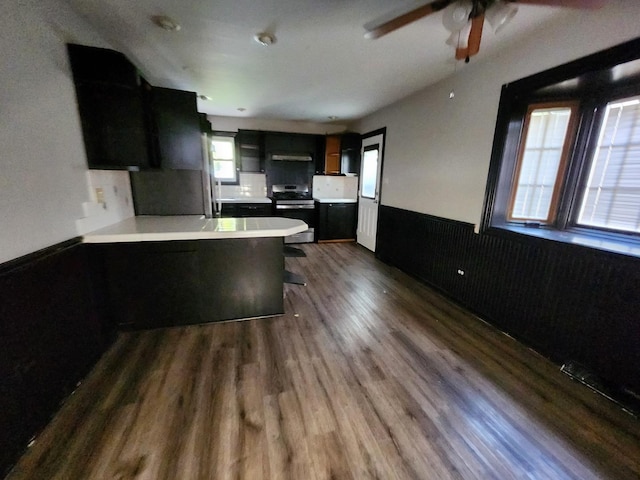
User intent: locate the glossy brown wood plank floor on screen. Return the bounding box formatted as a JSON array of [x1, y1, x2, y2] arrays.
[[8, 244, 640, 480]]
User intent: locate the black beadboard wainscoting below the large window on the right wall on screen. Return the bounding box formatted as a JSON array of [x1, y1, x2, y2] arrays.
[[376, 206, 640, 398]]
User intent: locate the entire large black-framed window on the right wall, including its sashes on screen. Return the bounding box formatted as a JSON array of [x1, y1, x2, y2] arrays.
[[482, 39, 640, 251]]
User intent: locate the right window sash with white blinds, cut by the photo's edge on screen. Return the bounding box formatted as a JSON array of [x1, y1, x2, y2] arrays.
[[576, 95, 640, 233]]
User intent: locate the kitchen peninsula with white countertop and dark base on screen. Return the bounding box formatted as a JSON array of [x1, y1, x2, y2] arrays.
[[83, 215, 307, 329]]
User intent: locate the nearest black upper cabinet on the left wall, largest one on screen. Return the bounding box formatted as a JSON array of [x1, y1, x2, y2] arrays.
[[67, 44, 149, 169]]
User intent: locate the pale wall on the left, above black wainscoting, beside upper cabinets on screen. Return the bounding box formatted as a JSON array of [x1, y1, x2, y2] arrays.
[[0, 0, 132, 262]]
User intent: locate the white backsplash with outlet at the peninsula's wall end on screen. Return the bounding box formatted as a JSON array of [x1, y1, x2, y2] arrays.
[[76, 170, 135, 235]]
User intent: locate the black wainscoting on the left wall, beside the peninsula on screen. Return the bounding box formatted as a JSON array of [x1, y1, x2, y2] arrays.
[[0, 240, 112, 477]]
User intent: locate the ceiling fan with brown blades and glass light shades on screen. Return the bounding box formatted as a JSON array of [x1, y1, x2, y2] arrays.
[[365, 0, 607, 62]]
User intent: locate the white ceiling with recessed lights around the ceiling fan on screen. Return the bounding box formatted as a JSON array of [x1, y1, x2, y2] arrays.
[[66, 0, 564, 123]]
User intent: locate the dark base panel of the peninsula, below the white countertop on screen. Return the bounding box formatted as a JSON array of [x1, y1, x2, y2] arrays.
[[92, 237, 284, 329]]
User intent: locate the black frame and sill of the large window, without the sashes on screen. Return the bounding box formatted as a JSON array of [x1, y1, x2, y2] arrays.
[[480, 39, 640, 256]]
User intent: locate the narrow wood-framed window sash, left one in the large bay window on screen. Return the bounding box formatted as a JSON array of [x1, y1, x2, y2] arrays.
[[507, 102, 578, 224]]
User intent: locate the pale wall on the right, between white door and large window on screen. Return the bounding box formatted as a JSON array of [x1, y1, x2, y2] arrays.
[[354, 0, 640, 224]]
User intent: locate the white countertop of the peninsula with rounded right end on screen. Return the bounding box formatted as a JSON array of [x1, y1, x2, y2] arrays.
[[83, 215, 308, 243]]
